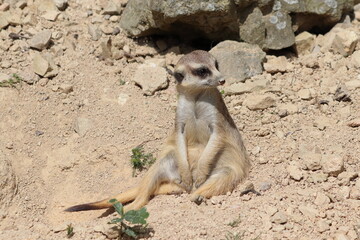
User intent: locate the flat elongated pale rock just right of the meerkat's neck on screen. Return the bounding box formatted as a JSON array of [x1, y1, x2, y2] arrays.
[[224, 79, 269, 95]]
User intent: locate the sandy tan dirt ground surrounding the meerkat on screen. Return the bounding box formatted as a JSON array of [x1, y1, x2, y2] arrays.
[[0, 1, 360, 240]]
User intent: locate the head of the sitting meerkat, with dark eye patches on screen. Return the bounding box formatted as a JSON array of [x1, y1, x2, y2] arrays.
[[174, 50, 225, 88]]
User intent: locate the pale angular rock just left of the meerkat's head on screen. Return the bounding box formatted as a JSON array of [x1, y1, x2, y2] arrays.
[[132, 63, 169, 96]]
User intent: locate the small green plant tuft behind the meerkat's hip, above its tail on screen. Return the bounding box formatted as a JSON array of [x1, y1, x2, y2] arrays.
[[130, 146, 156, 177]]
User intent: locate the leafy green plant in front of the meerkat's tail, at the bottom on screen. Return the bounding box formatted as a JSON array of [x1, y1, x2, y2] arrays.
[[109, 199, 149, 238]]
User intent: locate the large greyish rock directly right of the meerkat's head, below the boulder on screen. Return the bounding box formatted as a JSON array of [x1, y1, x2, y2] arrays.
[[210, 40, 265, 82]]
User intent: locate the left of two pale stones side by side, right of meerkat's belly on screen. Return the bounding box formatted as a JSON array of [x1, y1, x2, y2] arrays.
[[299, 144, 321, 171]]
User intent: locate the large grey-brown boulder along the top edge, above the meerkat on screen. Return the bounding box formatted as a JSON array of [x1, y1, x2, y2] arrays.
[[120, 0, 354, 50]]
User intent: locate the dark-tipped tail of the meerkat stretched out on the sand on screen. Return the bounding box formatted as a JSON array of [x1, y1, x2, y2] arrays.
[[65, 187, 138, 212]]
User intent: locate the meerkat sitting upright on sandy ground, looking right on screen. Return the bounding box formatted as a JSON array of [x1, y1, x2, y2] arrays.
[[65, 50, 250, 212]]
